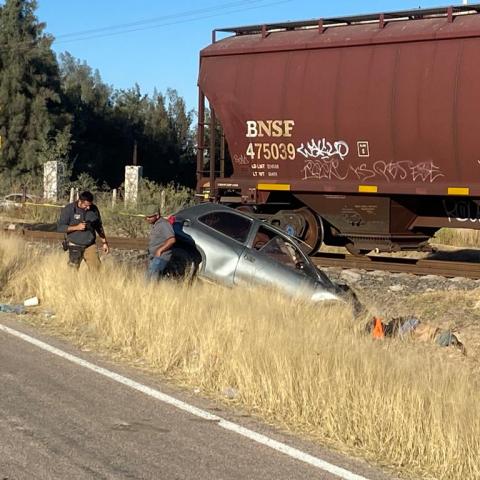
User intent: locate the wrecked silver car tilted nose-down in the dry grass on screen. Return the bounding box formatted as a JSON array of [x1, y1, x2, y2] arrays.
[[169, 203, 360, 311]]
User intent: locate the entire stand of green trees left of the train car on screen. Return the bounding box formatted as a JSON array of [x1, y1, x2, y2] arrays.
[[0, 0, 195, 187]]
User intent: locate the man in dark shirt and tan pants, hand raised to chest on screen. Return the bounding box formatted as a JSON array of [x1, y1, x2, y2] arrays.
[[57, 192, 110, 268]]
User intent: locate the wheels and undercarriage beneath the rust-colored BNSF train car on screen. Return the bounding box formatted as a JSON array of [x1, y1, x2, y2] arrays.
[[205, 179, 480, 255]]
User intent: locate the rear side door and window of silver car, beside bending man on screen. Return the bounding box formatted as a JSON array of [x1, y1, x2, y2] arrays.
[[194, 210, 253, 285]]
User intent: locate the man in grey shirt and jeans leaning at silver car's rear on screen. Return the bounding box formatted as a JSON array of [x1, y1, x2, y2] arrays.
[[145, 205, 175, 280]]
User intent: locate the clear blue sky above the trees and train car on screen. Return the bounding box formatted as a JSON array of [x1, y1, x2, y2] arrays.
[[32, 0, 472, 109]]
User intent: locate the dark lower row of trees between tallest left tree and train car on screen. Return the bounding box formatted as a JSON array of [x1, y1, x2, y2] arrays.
[[59, 53, 195, 186]]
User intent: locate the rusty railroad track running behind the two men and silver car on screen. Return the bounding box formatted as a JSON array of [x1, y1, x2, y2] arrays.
[[6, 229, 480, 279]]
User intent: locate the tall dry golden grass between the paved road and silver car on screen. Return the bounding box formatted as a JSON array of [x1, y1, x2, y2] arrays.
[[0, 240, 480, 480]]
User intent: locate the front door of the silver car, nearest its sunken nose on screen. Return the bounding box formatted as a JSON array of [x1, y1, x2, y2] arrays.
[[234, 224, 316, 294]]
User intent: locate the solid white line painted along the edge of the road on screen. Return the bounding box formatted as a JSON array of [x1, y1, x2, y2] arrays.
[[0, 324, 368, 480]]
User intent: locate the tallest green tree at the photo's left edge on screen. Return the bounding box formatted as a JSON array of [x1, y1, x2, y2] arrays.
[[0, 0, 70, 175]]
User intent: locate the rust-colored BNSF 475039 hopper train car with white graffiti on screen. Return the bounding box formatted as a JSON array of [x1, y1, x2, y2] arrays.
[[197, 5, 480, 253]]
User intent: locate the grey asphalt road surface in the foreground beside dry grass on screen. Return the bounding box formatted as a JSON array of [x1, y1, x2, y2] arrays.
[[0, 314, 396, 480]]
